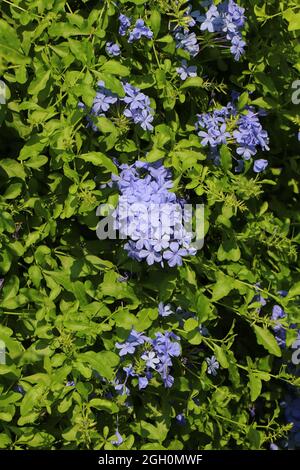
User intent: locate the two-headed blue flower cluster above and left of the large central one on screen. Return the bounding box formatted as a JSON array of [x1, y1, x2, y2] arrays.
[[78, 81, 154, 132]]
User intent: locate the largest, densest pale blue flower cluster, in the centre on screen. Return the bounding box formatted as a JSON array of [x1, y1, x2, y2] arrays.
[[112, 160, 196, 267]]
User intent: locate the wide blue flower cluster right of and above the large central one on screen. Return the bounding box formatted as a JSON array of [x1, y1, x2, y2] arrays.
[[196, 102, 269, 173]]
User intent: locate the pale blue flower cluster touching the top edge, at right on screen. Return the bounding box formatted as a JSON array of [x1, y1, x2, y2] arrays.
[[200, 0, 246, 61]]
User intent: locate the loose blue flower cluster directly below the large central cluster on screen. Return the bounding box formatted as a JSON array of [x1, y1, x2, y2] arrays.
[[115, 329, 181, 395]]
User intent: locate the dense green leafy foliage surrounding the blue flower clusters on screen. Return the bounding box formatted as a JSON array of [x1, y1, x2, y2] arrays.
[[0, 0, 300, 449]]
